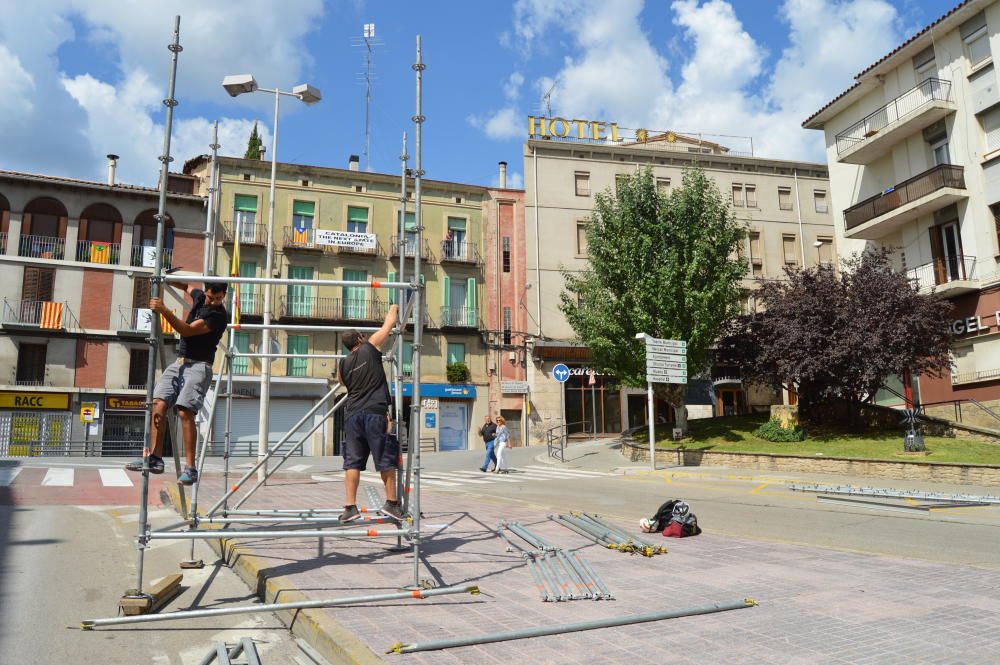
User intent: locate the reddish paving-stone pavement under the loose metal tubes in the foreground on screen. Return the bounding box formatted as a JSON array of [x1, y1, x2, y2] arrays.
[[188, 479, 1000, 665]]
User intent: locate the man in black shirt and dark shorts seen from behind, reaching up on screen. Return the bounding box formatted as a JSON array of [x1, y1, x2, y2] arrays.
[[340, 305, 405, 522]]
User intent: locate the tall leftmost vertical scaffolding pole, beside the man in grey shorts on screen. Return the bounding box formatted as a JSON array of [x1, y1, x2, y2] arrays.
[[131, 15, 183, 596]]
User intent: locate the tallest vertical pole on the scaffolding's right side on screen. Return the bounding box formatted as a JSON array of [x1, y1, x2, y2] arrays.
[[409, 35, 426, 589]]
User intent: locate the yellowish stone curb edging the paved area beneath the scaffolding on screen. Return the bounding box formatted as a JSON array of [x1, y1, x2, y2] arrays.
[[166, 485, 388, 665]]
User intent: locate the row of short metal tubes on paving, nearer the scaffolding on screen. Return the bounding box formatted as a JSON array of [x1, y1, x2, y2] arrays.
[[497, 520, 615, 602]]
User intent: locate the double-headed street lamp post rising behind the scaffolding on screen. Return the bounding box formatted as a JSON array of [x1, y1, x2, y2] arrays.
[[222, 74, 322, 480]]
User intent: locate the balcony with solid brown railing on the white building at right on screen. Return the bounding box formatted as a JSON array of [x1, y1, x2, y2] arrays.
[[844, 164, 968, 240]]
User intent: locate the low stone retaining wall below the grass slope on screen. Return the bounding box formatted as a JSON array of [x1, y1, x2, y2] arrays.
[[622, 442, 1000, 485]]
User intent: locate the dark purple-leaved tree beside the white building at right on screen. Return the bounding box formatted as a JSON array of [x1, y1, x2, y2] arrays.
[[721, 248, 952, 423]]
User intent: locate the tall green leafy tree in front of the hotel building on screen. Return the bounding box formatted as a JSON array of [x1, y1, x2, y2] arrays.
[[559, 168, 747, 432]]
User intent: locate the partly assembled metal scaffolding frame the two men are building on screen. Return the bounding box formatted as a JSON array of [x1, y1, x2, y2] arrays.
[[112, 23, 434, 627]]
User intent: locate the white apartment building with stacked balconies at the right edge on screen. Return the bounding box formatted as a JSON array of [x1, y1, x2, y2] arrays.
[[803, 0, 1000, 415]]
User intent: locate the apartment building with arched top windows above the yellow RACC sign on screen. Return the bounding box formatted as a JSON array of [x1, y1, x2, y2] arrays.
[[0, 166, 205, 455]]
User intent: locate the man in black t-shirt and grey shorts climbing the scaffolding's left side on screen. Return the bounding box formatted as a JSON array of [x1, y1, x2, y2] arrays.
[[125, 282, 229, 485]]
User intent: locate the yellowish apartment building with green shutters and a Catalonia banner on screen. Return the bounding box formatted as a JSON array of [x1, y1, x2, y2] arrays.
[[184, 156, 489, 454]]
